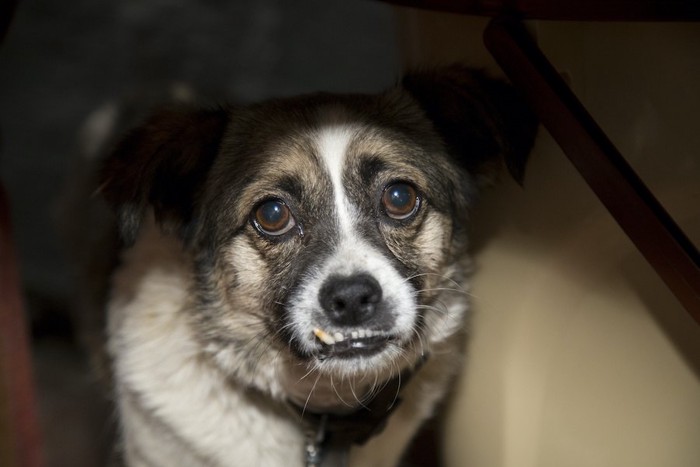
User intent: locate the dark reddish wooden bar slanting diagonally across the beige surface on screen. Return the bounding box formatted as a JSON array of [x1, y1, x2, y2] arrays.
[[484, 18, 700, 324]]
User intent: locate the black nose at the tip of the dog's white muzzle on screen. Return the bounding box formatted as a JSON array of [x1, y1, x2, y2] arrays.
[[318, 274, 382, 326]]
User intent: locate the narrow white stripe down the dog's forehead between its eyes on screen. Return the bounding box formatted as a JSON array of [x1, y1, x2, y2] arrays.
[[318, 125, 355, 236]]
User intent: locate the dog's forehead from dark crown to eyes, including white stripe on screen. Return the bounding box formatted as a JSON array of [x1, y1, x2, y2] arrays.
[[205, 99, 462, 245]]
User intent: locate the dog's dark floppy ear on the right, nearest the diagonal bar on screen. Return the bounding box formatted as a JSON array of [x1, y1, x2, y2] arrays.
[[401, 65, 537, 183]]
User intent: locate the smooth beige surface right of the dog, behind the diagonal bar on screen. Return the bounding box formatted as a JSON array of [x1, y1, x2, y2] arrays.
[[397, 9, 700, 467]]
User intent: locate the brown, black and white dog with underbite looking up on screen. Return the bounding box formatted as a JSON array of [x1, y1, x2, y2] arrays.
[[99, 65, 537, 467]]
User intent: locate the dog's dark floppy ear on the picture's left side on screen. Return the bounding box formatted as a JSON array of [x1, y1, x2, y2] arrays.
[[99, 109, 229, 244]]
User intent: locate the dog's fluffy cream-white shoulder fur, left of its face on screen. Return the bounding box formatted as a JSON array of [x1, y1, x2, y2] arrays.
[[108, 222, 301, 465]]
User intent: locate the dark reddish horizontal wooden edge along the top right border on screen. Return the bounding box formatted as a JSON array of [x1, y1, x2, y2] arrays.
[[383, 0, 700, 21]]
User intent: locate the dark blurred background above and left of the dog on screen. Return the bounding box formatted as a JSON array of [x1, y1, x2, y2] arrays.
[[0, 0, 400, 467]]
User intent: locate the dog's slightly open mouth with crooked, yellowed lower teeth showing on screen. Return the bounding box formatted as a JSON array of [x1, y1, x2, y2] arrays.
[[313, 328, 395, 359]]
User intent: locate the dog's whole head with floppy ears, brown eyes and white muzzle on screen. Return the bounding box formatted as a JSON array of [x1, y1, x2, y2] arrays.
[[103, 67, 536, 408]]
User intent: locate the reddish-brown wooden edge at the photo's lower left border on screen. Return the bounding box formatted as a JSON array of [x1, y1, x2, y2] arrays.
[[0, 184, 42, 467]]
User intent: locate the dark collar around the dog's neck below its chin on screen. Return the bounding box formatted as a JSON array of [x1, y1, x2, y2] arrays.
[[287, 355, 428, 467]]
